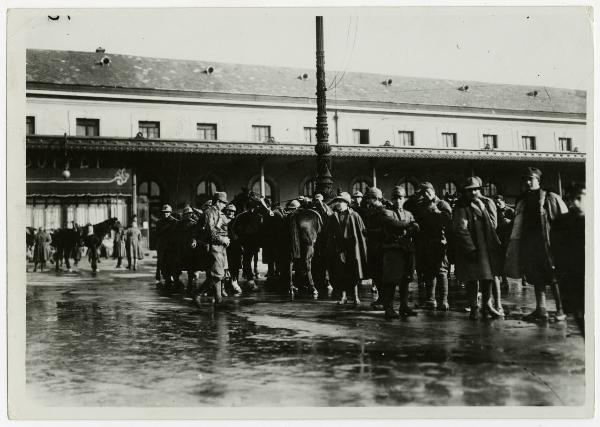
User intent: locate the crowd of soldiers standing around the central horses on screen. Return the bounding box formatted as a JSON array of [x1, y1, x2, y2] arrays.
[[150, 167, 585, 327]]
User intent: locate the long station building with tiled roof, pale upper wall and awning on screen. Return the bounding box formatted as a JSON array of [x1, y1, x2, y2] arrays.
[[25, 48, 587, 248]]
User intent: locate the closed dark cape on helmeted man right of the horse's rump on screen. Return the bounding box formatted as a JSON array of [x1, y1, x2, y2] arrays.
[[325, 208, 367, 285]]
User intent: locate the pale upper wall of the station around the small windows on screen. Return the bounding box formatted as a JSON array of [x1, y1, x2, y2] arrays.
[[27, 97, 586, 152]]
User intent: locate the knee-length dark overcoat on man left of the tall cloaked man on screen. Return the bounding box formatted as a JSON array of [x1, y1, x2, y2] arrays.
[[453, 196, 503, 281]]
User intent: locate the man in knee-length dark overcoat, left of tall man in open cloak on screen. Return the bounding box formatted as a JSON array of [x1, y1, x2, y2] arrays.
[[452, 176, 504, 319]]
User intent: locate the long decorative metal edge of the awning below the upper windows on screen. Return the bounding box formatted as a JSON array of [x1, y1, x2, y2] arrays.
[[27, 135, 586, 163]]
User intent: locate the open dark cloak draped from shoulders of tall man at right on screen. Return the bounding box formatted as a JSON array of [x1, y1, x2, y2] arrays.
[[504, 190, 568, 280]]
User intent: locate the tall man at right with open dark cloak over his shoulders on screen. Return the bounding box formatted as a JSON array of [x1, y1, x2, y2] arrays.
[[504, 167, 568, 321]]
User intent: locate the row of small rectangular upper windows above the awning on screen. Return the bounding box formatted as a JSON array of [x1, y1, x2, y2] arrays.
[[27, 116, 573, 151]]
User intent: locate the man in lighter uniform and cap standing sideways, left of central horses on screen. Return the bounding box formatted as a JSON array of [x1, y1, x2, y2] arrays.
[[196, 191, 230, 305]]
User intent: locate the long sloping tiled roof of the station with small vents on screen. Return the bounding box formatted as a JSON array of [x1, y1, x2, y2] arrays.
[[27, 49, 586, 114]]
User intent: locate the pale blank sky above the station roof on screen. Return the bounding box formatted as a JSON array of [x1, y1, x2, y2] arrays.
[[16, 7, 593, 89]]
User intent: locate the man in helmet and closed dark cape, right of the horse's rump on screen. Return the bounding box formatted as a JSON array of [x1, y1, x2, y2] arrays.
[[325, 192, 367, 305]]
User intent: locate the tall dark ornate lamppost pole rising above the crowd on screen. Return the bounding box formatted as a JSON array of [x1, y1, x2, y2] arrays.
[[315, 16, 333, 200]]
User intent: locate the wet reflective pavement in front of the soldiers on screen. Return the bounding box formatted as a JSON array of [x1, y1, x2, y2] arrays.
[[26, 259, 585, 406]]
